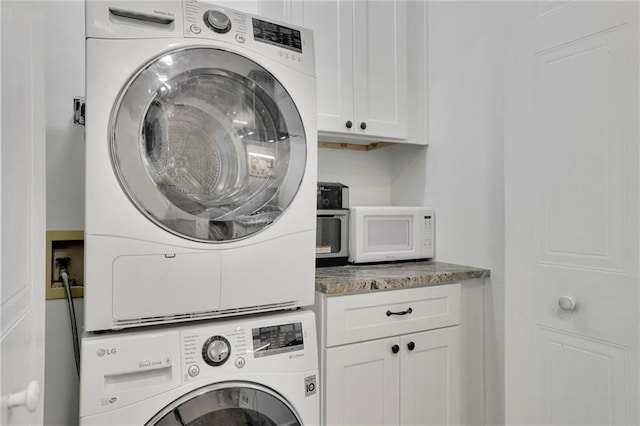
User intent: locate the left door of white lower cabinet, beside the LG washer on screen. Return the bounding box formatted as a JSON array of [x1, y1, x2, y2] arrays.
[[324, 338, 400, 426]]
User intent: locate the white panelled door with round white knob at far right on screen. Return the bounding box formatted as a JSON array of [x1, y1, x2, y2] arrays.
[[505, 1, 639, 425]]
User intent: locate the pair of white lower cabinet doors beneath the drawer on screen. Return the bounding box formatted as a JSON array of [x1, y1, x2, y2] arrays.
[[324, 326, 460, 425]]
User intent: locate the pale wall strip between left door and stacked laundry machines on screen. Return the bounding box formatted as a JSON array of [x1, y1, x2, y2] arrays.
[[44, 1, 84, 426]]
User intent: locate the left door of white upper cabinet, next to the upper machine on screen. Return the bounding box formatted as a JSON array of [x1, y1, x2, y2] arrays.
[[294, 0, 354, 133]]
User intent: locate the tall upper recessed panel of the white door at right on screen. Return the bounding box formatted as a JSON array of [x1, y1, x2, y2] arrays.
[[533, 26, 633, 272]]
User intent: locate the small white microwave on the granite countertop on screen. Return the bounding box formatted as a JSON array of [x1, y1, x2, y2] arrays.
[[349, 207, 435, 263]]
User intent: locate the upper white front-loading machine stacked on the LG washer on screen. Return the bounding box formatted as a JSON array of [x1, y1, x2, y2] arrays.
[[84, 0, 317, 331]]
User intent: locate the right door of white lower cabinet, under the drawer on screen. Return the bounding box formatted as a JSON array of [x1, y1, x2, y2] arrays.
[[400, 326, 461, 425]]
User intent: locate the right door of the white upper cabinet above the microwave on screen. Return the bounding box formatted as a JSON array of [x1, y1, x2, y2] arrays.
[[353, 0, 408, 139]]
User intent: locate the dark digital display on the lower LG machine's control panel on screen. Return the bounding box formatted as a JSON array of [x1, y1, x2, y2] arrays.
[[251, 322, 304, 358]]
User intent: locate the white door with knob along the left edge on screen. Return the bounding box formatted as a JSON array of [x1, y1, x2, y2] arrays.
[[0, 1, 46, 426]]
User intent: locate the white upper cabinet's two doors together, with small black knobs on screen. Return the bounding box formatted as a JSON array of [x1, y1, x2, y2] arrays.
[[292, 0, 408, 141]]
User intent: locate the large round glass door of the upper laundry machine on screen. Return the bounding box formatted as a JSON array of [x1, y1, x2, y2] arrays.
[[111, 47, 307, 242]]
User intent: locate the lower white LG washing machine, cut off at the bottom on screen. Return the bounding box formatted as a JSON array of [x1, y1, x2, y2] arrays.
[[80, 310, 320, 426]]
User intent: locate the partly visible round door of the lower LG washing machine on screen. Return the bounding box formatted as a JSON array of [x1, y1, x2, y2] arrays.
[[145, 382, 302, 426]]
